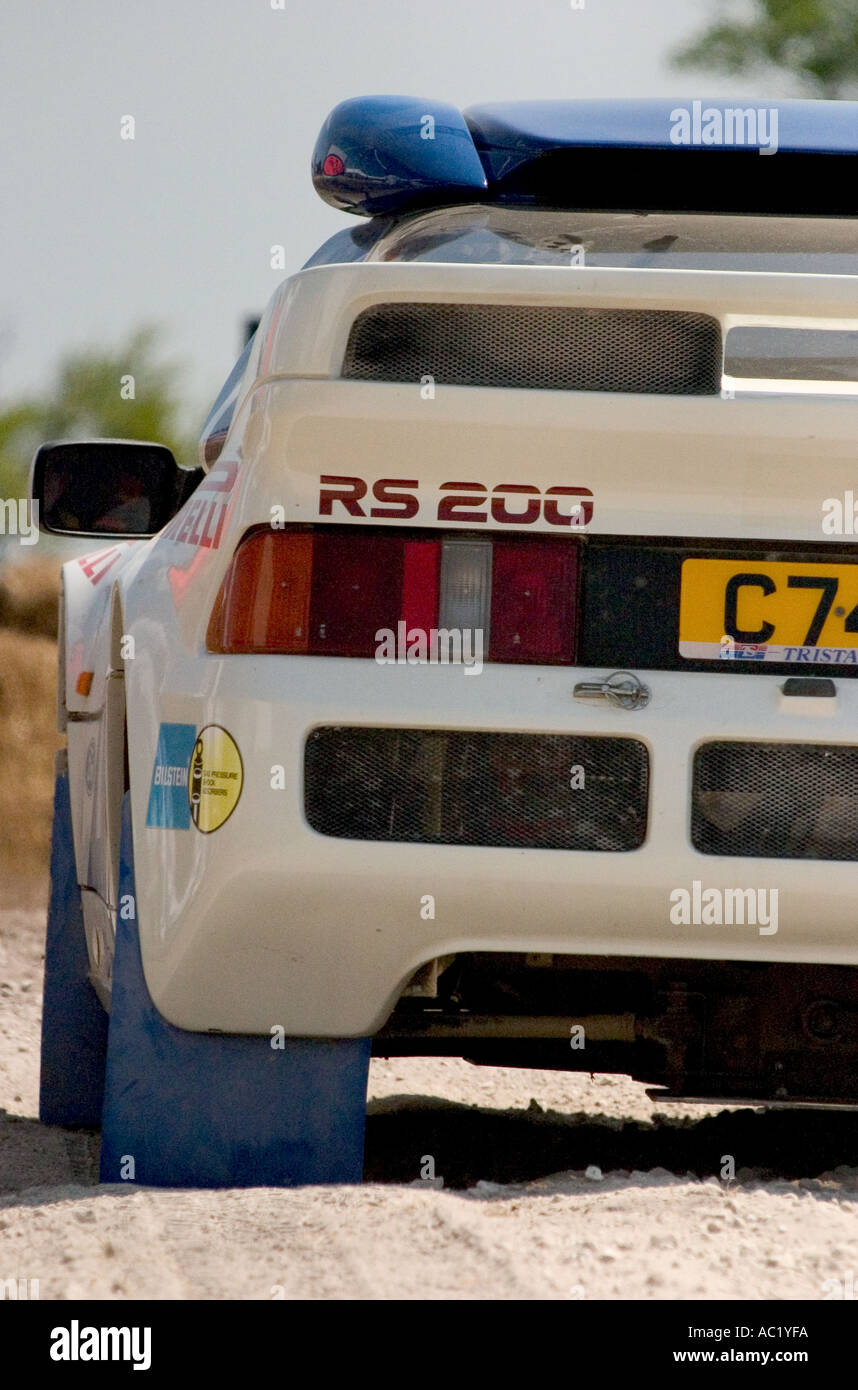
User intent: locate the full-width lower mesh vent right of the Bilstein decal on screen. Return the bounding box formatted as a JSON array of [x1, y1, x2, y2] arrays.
[[305, 728, 649, 851]]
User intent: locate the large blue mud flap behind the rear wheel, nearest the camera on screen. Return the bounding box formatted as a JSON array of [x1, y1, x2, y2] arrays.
[[102, 795, 370, 1187]]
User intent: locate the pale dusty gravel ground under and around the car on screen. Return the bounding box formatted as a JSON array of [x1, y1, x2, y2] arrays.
[[0, 910, 858, 1300]]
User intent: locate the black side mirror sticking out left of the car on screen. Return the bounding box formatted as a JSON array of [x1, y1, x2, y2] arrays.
[[29, 439, 203, 537]]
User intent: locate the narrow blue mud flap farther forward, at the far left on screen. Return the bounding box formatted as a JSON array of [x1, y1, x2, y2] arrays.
[[39, 755, 107, 1126]]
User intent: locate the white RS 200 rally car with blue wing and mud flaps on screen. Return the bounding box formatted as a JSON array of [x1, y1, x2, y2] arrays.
[[32, 97, 858, 1186]]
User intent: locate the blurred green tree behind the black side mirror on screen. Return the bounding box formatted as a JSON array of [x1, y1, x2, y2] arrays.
[[0, 328, 196, 505]]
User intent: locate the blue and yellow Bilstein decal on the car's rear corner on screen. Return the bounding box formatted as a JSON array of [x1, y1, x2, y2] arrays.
[[146, 724, 245, 835]]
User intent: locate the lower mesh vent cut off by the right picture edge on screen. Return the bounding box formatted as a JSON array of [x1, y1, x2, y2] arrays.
[[691, 744, 858, 859]]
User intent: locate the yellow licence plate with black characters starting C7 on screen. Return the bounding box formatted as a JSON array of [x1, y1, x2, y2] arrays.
[[679, 559, 858, 666]]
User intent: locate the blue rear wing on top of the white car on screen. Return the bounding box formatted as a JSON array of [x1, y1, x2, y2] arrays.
[[313, 96, 858, 217]]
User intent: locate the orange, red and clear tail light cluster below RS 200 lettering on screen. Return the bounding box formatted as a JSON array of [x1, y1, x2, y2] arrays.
[[207, 527, 578, 664]]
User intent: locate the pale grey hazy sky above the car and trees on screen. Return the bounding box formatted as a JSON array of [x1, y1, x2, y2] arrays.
[[0, 0, 795, 424]]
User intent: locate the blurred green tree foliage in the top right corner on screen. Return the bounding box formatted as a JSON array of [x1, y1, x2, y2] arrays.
[[673, 0, 858, 97]]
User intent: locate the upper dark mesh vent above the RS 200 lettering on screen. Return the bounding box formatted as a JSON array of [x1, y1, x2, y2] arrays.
[[342, 304, 722, 396]]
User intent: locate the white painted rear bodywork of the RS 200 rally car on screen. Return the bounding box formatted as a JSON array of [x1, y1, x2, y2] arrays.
[[58, 264, 858, 1037]]
